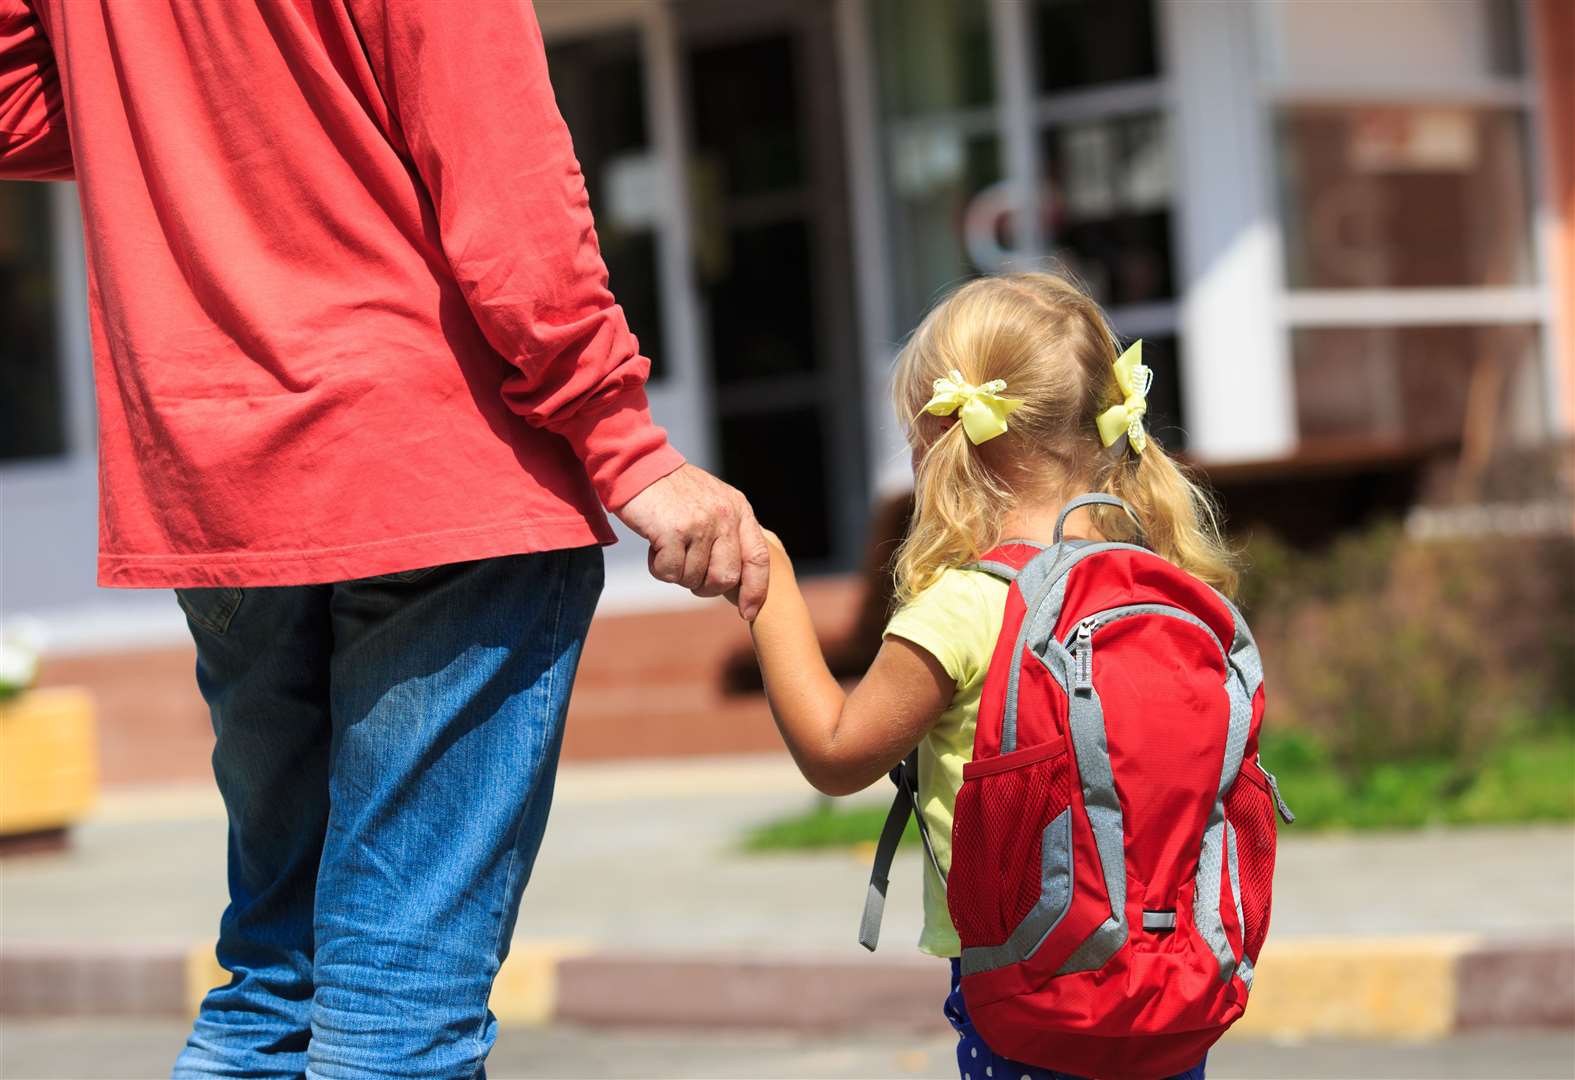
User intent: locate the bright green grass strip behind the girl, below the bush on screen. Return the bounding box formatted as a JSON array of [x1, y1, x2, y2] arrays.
[[742, 715, 1575, 852]]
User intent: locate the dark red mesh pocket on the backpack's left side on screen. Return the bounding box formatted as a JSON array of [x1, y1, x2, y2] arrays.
[[947, 745, 1071, 948]]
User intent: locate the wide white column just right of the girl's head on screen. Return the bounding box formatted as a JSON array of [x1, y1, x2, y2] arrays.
[[1159, 0, 1296, 461]]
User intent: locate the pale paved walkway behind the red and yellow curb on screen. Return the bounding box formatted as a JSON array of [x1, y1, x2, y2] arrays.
[[0, 756, 1575, 959]]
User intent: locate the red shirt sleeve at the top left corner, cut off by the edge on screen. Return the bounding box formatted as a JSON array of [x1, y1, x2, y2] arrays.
[[0, 0, 72, 179]]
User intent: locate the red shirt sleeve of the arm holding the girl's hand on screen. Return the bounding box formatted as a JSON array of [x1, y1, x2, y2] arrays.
[[348, 0, 684, 509]]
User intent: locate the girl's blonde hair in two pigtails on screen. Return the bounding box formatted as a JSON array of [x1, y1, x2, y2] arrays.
[[893, 274, 1236, 603]]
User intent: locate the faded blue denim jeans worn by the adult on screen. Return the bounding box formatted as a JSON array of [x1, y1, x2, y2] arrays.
[[175, 548, 602, 1080]]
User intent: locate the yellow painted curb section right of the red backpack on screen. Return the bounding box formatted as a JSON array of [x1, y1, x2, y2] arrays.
[[1227, 937, 1477, 1039]]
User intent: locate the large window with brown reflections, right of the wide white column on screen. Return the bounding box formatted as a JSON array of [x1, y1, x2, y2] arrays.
[[1263, 0, 1544, 452]]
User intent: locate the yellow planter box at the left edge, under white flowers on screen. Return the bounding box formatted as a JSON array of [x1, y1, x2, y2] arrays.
[[0, 686, 98, 836]]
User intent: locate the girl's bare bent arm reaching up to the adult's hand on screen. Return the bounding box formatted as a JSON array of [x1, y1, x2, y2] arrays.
[[751, 534, 956, 795]]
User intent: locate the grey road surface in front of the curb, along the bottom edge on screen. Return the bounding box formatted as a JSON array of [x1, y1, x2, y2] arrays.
[[0, 1019, 1575, 1080]]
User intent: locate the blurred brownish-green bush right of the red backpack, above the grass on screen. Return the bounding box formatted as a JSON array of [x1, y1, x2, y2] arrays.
[[1241, 524, 1575, 787]]
